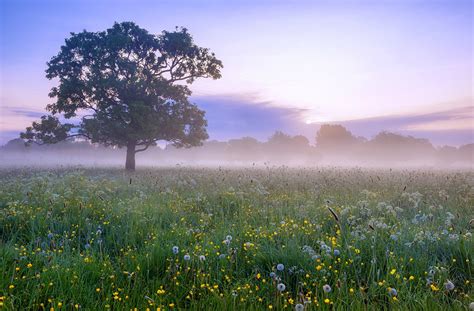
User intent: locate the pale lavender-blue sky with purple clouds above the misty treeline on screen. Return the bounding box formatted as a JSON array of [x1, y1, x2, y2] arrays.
[[0, 0, 474, 146]]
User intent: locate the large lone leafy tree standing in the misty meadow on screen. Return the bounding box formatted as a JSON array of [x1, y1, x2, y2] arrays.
[[20, 22, 223, 170]]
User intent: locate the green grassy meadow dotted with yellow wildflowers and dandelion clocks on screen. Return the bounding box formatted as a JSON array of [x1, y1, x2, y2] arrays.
[[0, 167, 474, 311]]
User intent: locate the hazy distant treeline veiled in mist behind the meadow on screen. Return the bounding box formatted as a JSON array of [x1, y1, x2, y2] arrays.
[[0, 124, 474, 166]]
